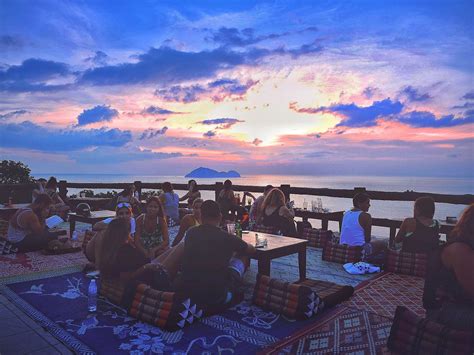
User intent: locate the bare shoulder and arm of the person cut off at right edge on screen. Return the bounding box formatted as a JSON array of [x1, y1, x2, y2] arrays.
[[441, 243, 474, 300]]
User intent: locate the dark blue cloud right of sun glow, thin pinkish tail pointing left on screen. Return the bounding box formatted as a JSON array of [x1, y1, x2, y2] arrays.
[[290, 98, 403, 127]]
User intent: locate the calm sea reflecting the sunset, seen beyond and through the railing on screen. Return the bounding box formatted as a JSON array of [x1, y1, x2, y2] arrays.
[[33, 173, 474, 236]]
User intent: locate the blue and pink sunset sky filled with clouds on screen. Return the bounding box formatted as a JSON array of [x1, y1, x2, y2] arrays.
[[0, 0, 474, 177]]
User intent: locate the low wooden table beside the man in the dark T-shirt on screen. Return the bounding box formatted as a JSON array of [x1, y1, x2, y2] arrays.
[[242, 232, 308, 280]]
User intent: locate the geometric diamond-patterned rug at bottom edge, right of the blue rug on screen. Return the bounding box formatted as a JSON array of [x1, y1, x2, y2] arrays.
[[261, 306, 392, 355]]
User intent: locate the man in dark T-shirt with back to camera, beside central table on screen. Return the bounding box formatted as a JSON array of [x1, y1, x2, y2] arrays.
[[175, 200, 255, 307]]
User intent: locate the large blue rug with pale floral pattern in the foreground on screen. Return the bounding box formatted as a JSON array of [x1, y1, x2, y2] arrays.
[[0, 272, 326, 354]]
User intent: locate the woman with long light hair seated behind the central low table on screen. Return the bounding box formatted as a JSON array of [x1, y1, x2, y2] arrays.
[[258, 188, 297, 237]]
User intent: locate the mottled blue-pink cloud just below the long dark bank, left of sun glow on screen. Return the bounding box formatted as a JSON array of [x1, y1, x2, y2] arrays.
[[155, 78, 258, 103]]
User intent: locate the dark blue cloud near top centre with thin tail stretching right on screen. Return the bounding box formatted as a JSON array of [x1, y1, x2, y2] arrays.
[[206, 27, 317, 47]]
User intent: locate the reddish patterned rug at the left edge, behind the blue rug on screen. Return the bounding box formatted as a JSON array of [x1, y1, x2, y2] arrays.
[[0, 251, 87, 281]]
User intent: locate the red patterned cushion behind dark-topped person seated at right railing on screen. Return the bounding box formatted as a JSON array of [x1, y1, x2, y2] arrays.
[[385, 250, 428, 277]]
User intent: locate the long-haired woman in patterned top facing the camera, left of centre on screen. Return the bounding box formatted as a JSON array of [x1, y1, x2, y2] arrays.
[[135, 196, 169, 260]]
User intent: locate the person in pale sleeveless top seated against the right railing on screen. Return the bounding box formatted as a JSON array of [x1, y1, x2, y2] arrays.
[[340, 192, 386, 256]]
